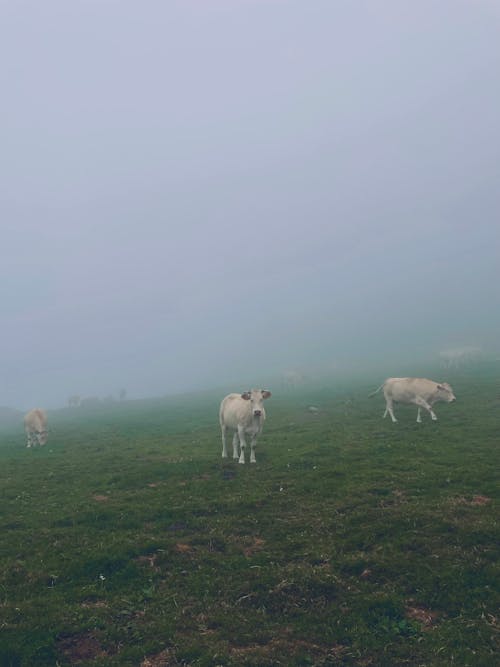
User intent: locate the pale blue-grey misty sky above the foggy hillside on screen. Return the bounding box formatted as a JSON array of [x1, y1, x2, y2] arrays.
[[0, 0, 500, 408]]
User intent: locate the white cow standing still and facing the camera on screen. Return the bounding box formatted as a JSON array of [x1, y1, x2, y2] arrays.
[[219, 389, 271, 463]]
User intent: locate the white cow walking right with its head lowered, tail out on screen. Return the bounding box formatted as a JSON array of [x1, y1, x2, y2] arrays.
[[370, 378, 456, 423]]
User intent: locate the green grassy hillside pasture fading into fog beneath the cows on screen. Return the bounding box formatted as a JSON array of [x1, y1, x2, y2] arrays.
[[0, 369, 500, 667]]
